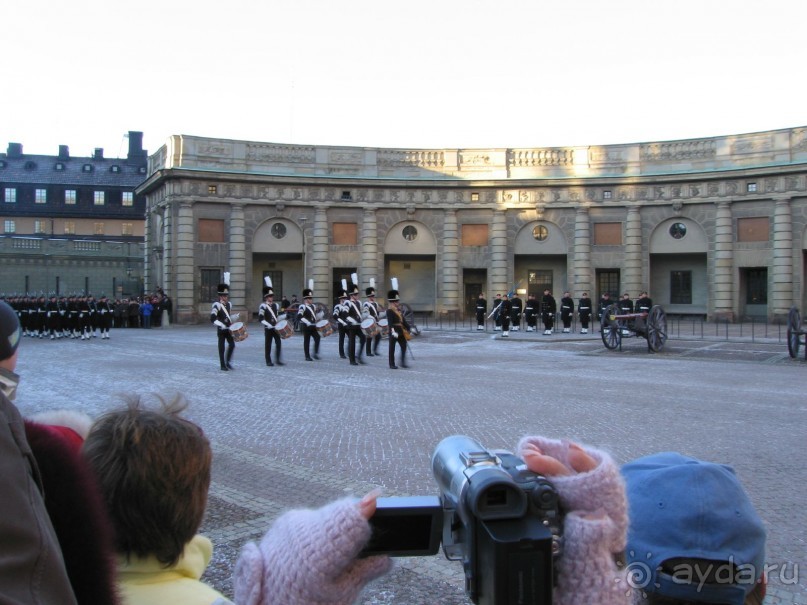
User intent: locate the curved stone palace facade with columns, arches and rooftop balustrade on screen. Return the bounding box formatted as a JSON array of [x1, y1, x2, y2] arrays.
[[136, 127, 807, 323]]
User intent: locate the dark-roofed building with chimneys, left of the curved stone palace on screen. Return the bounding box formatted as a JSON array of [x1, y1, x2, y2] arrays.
[[0, 131, 148, 297]]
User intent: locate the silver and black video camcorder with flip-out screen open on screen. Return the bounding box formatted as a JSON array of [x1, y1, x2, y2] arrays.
[[363, 435, 563, 605]]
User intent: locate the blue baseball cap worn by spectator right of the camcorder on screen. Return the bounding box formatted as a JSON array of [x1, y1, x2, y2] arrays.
[[622, 452, 765, 605]]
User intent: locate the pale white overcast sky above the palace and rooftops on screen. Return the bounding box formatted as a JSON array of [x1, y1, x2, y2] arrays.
[[0, 0, 807, 157]]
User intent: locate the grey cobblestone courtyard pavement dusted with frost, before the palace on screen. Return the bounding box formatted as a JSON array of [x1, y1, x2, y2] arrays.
[[17, 325, 807, 605]]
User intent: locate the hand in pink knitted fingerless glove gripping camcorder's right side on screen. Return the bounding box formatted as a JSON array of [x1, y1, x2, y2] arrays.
[[516, 436, 631, 605]]
